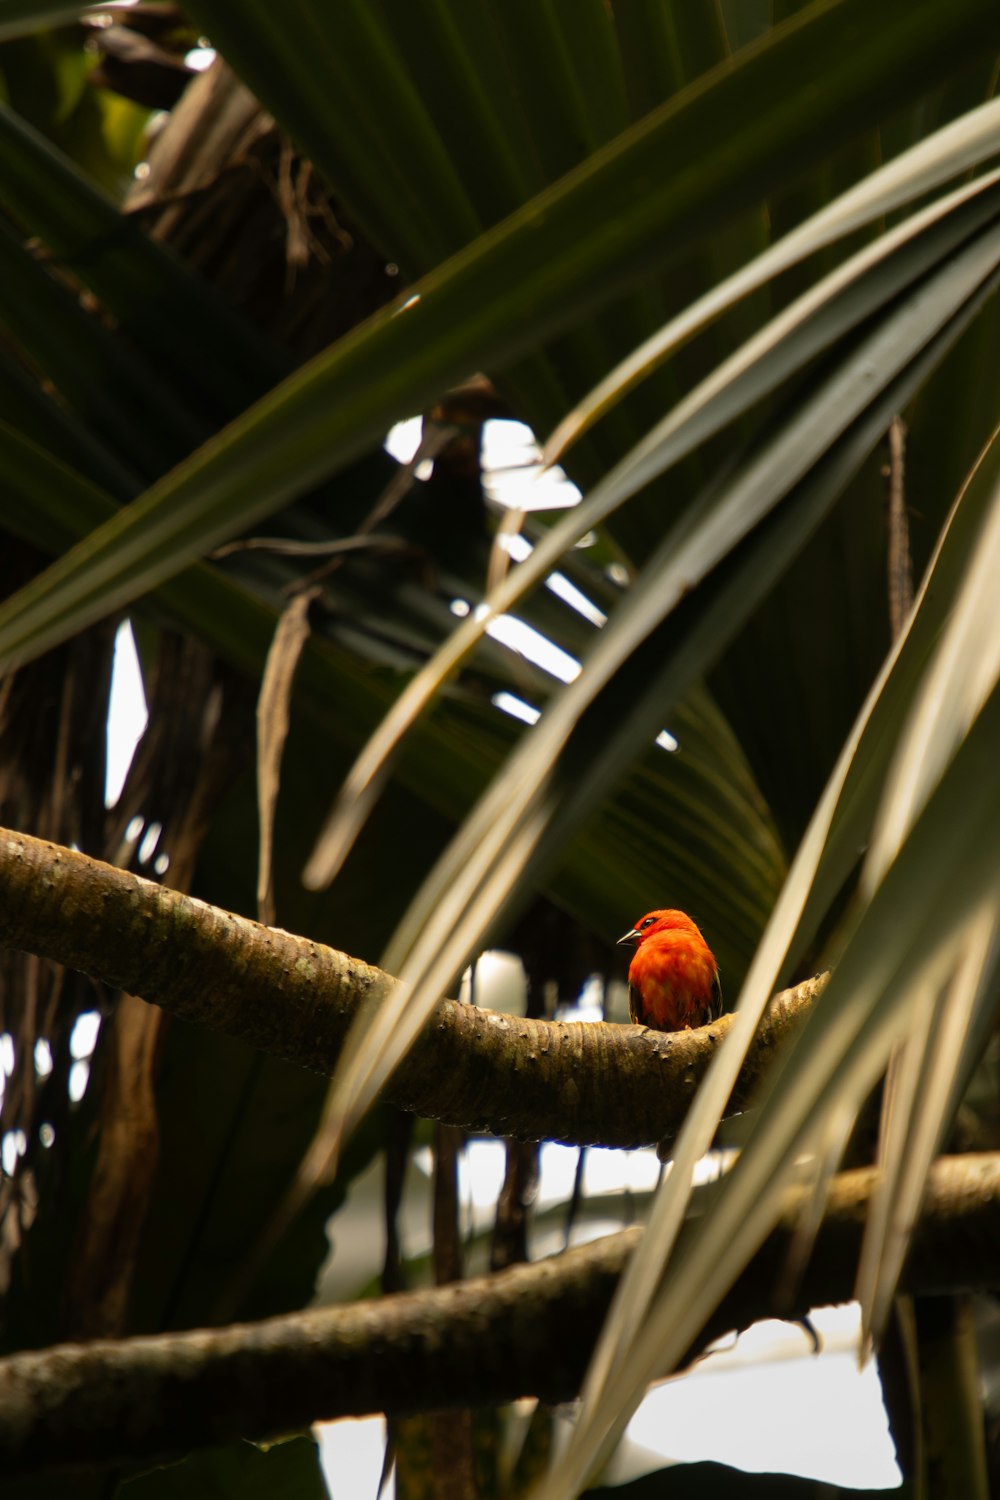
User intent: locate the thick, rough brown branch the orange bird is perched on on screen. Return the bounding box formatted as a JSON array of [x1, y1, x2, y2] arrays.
[[0, 830, 825, 1146]]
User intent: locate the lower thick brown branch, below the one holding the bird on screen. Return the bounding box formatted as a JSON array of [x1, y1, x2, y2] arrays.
[[0, 1155, 1000, 1473]]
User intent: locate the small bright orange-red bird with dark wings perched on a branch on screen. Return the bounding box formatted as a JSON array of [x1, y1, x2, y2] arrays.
[[618, 912, 723, 1031]]
